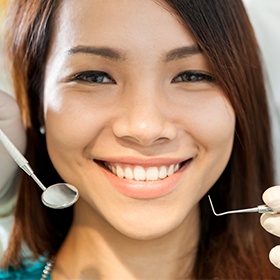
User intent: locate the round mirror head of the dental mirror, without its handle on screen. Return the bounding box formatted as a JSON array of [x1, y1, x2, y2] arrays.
[[42, 183, 79, 209]]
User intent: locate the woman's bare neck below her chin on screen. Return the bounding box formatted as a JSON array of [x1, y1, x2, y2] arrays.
[[52, 200, 199, 280]]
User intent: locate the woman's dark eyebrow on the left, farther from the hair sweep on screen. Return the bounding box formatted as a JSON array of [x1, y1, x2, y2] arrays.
[[66, 45, 125, 61]]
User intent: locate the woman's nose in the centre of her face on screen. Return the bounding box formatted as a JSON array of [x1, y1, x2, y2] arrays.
[[113, 86, 177, 147]]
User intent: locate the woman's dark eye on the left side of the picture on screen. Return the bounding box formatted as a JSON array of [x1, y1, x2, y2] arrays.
[[71, 71, 116, 84]]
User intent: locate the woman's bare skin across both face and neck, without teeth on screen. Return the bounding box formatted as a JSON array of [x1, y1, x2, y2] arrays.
[[44, 0, 235, 279]]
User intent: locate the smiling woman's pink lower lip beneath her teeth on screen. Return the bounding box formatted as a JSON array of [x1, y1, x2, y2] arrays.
[[98, 160, 191, 199]]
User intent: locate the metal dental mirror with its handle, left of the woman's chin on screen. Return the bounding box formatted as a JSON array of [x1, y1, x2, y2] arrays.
[[0, 129, 79, 209]]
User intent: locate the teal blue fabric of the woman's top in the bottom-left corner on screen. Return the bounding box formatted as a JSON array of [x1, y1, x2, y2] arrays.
[[0, 258, 51, 280]]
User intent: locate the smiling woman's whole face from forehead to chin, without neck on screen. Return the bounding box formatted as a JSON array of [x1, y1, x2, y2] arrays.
[[44, 0, 235, 239]]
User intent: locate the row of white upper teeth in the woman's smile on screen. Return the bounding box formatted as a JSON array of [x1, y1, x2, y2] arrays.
[[105, 163, 180, 181]]
